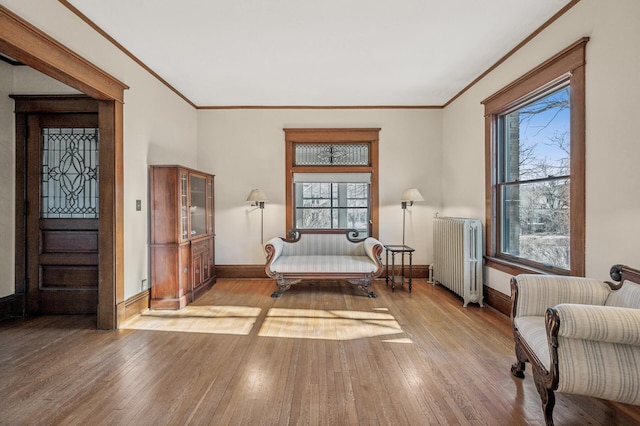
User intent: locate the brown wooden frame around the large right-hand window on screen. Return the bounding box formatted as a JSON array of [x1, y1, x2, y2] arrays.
[[482, 37, 589, 276]]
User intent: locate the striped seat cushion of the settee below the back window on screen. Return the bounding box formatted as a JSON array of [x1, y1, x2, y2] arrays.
[[271, 255, 377, 274]]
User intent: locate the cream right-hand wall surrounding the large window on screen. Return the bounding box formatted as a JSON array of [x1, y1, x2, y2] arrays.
[[442, 0, 640, 294]]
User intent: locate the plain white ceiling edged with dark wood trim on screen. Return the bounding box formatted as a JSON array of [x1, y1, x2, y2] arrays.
[[69, 0, 569, 106]]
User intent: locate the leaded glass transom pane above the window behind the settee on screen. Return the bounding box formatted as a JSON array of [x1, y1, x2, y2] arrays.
[[294, 143, 369, 166]]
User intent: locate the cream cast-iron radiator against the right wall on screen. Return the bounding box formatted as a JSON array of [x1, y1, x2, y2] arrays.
[[432, 217, 483, 307]]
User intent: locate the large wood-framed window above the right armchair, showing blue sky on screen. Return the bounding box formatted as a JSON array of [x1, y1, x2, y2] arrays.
[[483, 39, 588, 275]]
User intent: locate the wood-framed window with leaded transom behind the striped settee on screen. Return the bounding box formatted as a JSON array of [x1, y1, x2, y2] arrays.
[[285, 129, 380, 237]]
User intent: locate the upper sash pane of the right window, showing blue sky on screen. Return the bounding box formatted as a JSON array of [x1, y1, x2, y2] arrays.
[[499, 86, 571, 182]]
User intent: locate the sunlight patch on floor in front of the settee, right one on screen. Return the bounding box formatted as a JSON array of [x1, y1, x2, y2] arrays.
[[258, 308, 410, 340]]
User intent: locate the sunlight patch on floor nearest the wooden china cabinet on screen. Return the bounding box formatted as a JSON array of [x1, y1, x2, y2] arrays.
[[120, 305, 261, 335]]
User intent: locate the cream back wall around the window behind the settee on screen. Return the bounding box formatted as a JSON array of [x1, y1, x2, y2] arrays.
[[198, 109, 442, 265]]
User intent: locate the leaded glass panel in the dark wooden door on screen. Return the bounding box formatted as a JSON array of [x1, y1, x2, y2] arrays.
[[41, 128, 99, 219]]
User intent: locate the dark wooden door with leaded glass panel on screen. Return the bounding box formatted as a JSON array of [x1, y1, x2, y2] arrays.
[[25, 113, 99, 314]]
